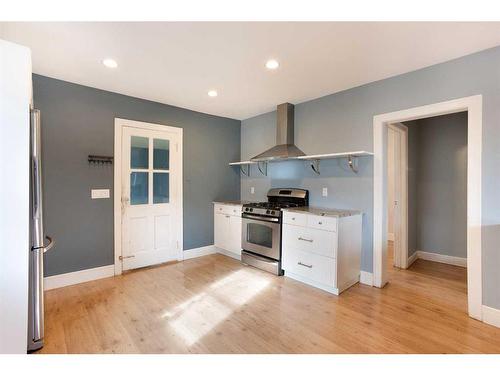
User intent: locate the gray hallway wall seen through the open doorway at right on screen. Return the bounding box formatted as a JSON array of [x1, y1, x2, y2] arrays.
[[405, 112, 467, 258]]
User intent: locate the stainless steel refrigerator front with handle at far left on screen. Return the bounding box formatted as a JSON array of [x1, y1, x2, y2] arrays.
[[28, 109, 54, 351]]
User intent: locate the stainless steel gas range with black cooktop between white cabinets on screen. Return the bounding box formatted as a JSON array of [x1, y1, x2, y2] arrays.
[[241, 188, 309, 275]]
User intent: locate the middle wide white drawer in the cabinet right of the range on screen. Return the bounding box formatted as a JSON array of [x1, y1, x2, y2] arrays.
[[283, 224, 337, 258]]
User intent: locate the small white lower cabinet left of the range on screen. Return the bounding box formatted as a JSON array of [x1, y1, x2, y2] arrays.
[[214, 204, 241, 259]]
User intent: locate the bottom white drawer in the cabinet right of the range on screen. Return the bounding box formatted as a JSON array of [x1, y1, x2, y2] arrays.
[[283, 249, 337, 288]]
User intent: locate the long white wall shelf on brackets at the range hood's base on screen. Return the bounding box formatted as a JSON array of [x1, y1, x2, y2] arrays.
[[229, 151, 373, 176]]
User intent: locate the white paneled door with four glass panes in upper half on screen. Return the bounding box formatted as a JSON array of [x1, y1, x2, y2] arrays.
[[121, 126, 182, 270]]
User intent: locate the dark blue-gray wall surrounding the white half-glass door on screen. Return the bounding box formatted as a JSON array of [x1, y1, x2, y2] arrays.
[[33, 75, 240, 276]]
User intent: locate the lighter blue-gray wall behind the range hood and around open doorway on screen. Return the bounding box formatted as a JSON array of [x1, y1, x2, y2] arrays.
[[241, 48, 500, 308]]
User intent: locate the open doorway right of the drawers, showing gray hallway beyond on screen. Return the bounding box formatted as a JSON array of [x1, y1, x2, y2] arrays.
[[387, 112, 467, 274]]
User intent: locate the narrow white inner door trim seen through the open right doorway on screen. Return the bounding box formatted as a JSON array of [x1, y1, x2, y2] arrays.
[[388, 123, 408, 269]]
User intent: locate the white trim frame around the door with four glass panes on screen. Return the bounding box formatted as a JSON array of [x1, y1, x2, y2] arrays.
[[113, 118, 184, 275]]
